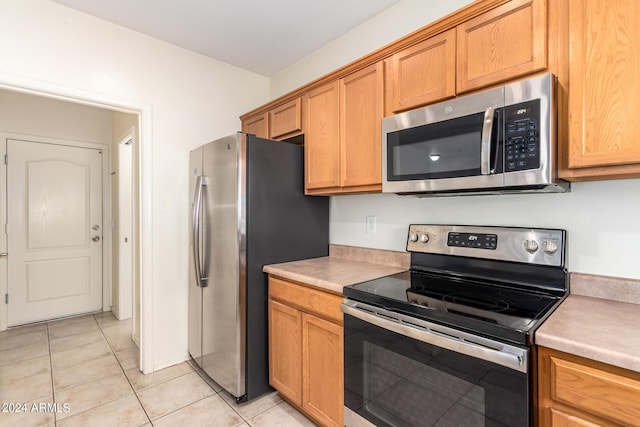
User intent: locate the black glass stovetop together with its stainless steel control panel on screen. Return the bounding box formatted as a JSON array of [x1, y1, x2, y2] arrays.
[[344, 226, 567, 344]]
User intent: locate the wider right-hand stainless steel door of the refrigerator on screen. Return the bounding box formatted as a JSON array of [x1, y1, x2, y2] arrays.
[[202, 135, 246, 397]]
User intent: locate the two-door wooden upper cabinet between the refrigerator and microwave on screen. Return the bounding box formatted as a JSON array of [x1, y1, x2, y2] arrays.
[[303, 61, 384, 195]]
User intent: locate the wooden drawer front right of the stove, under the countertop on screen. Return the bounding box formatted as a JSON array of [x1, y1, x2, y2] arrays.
[[551, 357, 640, 425]]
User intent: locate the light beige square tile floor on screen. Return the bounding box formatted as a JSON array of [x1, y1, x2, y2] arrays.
[[0, 312, 314, 427]]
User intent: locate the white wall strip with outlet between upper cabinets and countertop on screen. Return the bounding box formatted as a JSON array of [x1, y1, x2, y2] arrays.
[[330, 179, 640, 279]]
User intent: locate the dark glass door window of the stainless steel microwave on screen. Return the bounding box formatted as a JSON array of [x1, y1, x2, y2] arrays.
[[387, 113, 497, 181]]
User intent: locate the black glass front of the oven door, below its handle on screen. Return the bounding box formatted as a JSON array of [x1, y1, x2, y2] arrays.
[[344, 315, 530, 427]]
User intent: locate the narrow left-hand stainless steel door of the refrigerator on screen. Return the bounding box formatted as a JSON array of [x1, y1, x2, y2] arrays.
[[189, 147, 203, 367]]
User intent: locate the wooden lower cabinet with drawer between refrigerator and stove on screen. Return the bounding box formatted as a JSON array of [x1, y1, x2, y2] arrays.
[[269, 276, 344, 426]]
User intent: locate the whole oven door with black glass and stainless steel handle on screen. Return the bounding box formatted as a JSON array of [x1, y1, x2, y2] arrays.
[[341, 300, 532, 427]]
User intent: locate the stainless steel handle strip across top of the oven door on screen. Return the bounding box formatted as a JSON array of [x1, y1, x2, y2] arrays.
[[340, 299, 529, 373]]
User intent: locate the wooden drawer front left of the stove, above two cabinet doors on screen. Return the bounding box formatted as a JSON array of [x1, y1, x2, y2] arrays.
[[269, 276, 343, 325]]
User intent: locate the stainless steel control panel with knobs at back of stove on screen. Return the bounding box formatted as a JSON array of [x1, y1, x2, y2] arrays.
[[407, 224, 565, 266]]
